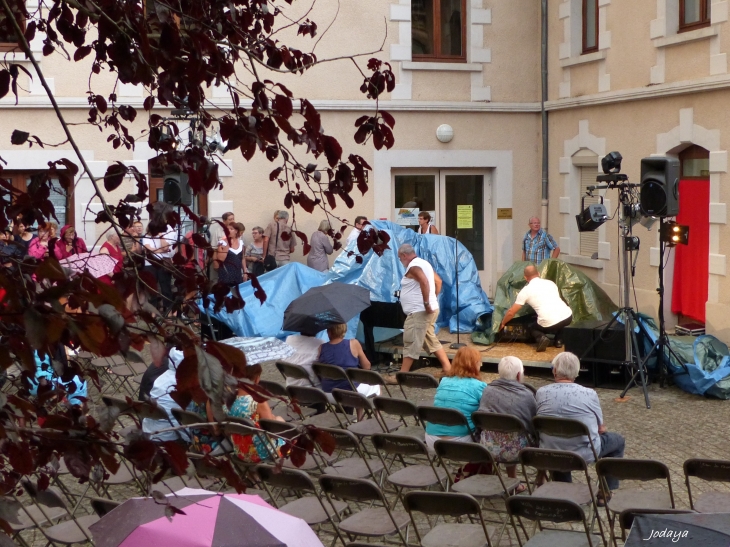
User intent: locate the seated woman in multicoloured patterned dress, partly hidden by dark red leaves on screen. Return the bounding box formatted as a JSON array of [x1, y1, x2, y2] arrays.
[[225, 365, 284, 463]]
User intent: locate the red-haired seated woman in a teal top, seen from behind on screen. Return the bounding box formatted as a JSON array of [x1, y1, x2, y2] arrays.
[[426, 347, 487, 449]]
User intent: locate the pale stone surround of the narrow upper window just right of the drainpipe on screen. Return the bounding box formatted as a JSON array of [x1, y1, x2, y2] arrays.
[[558, 0, 611, 99]]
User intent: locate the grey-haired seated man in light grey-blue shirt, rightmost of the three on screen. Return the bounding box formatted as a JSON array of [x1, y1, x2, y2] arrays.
[[535, 351, 625, 494]]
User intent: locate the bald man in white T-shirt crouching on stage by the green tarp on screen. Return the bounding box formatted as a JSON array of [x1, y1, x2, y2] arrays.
[[499, 264, 573, 351]]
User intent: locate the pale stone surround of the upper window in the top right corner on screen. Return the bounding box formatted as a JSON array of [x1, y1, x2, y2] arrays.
[[649, 0, 728, 84]]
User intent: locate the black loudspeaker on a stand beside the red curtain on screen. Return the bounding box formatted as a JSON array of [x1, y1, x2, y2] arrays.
[[639, 157, 679, 217]]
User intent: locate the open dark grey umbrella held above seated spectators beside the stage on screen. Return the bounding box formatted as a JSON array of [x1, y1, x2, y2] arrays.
[[283, 283, 370, 335]]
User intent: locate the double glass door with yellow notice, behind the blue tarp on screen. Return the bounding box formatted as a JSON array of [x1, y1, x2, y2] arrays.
[[393, 170, 491, 290]]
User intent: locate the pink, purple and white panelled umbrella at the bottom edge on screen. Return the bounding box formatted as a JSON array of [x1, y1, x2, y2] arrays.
[[89, 488, 323, 547]]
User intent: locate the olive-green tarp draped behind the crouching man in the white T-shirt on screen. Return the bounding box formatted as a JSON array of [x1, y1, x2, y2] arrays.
[[471, 258, 618, 345]]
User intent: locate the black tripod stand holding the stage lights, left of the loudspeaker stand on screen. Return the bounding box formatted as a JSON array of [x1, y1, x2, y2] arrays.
[[580, 183, 651, 408]]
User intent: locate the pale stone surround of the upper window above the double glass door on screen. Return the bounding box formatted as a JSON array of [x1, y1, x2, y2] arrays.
[[390, 0, 492, 102]]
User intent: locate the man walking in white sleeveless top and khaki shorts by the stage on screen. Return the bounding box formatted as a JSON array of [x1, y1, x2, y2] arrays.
[[384, 243, 451, 384]]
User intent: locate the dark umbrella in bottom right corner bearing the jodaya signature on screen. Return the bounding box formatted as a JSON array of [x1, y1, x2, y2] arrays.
[[626, 513, 730, 547]]
